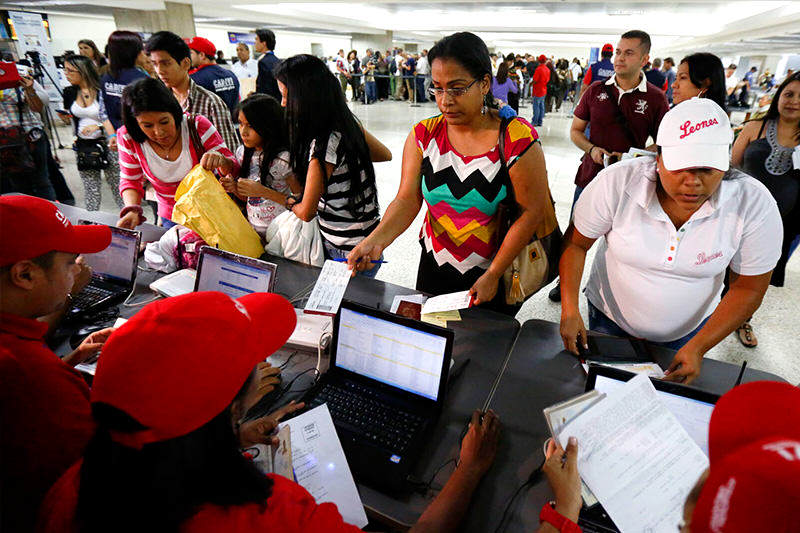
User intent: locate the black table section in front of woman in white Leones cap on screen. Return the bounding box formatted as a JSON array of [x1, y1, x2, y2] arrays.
[[464, 320, 784, 533]]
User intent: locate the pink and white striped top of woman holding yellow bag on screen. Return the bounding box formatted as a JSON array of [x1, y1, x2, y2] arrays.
[[117, 113, 239, 219]]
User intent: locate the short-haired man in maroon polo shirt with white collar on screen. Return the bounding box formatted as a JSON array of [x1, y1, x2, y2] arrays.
[[549, 30, 669, 302]]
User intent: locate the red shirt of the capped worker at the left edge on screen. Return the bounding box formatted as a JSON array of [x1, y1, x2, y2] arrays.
[[0, 313, 94, 532]]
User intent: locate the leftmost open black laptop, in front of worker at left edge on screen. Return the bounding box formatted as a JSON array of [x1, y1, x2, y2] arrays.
[[68, 220, 142, 318]]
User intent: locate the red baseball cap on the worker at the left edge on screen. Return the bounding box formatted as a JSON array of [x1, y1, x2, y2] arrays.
[[0, 195, 111, 266]]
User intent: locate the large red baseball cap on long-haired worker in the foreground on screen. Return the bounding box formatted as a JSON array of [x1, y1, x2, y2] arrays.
[[91, 292, 297, 449]]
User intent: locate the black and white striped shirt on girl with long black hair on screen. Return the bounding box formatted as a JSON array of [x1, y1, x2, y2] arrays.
[[309, 131, 380, 250]]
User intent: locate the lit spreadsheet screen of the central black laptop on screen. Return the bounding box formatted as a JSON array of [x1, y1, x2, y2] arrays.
[[336, 308, 447, 400]]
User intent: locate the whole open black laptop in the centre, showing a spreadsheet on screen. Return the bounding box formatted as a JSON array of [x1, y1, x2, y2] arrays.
[[303, 300, 453, 492]]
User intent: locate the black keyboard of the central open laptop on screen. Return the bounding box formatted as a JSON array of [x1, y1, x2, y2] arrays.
[[309, 382, 422, 454]]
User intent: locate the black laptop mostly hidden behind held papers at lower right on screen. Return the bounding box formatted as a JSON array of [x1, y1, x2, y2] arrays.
[[578, 364, 719, 533]]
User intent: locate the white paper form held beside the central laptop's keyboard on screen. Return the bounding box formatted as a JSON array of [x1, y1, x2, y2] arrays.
[[281, 406, 368, 528]]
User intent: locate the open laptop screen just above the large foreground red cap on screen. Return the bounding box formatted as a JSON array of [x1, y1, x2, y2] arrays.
[[194, 247, 276, 298]]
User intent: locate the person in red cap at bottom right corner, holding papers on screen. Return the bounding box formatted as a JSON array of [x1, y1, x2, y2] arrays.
[[537, 381, 800, 533]]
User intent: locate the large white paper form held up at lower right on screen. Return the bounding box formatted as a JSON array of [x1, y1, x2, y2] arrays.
[[559, 375, 708, 533]]
